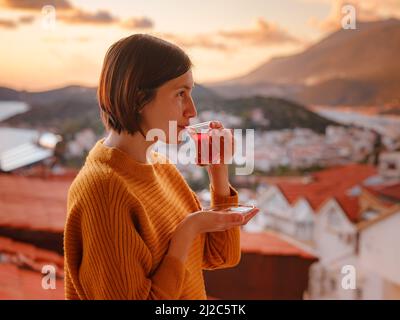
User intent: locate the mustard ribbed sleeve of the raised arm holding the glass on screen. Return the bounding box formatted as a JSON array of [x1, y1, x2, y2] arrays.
[[203, 184, 241, 270]]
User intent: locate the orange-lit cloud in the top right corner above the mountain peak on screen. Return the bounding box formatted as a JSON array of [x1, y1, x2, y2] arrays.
[[308, 0, 400, 32]]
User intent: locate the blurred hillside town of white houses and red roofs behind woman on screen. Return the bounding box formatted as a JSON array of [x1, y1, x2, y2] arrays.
[[0, 103, 400, 299]]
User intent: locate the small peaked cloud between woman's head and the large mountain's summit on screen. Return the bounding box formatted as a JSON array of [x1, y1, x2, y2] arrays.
[[218, 18, 300, 46]]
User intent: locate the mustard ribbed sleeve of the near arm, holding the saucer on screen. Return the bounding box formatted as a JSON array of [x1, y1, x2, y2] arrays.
[[65, 171, 186, 300]]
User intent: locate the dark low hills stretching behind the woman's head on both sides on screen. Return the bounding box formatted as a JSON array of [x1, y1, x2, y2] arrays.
[[1, 84, 335, 135]]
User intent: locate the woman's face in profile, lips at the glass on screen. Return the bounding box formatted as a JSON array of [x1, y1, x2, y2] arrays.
[[141, 70, 197, 143]]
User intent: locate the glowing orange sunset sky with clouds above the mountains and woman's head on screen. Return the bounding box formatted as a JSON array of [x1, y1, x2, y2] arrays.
[[0, 0, 400, 90]]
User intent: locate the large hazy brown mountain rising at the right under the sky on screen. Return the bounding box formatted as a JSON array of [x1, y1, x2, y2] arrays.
[[208, 19, 400, 105]]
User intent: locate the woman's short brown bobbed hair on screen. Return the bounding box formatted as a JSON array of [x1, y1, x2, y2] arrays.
[[97, 34, 193, 136]]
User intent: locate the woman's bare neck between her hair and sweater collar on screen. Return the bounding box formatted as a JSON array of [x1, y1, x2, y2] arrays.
[[103, 130, 154, 163]]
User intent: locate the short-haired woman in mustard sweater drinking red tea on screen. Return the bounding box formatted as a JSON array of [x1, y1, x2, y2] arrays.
[[64, 34, 255, 299]]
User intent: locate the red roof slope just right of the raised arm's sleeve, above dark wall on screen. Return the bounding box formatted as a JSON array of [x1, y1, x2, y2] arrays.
[[240, 231, 316, 259]]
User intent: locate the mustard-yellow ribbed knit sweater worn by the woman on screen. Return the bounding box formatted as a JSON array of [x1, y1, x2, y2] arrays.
[[64, 138, 240, 300]]
